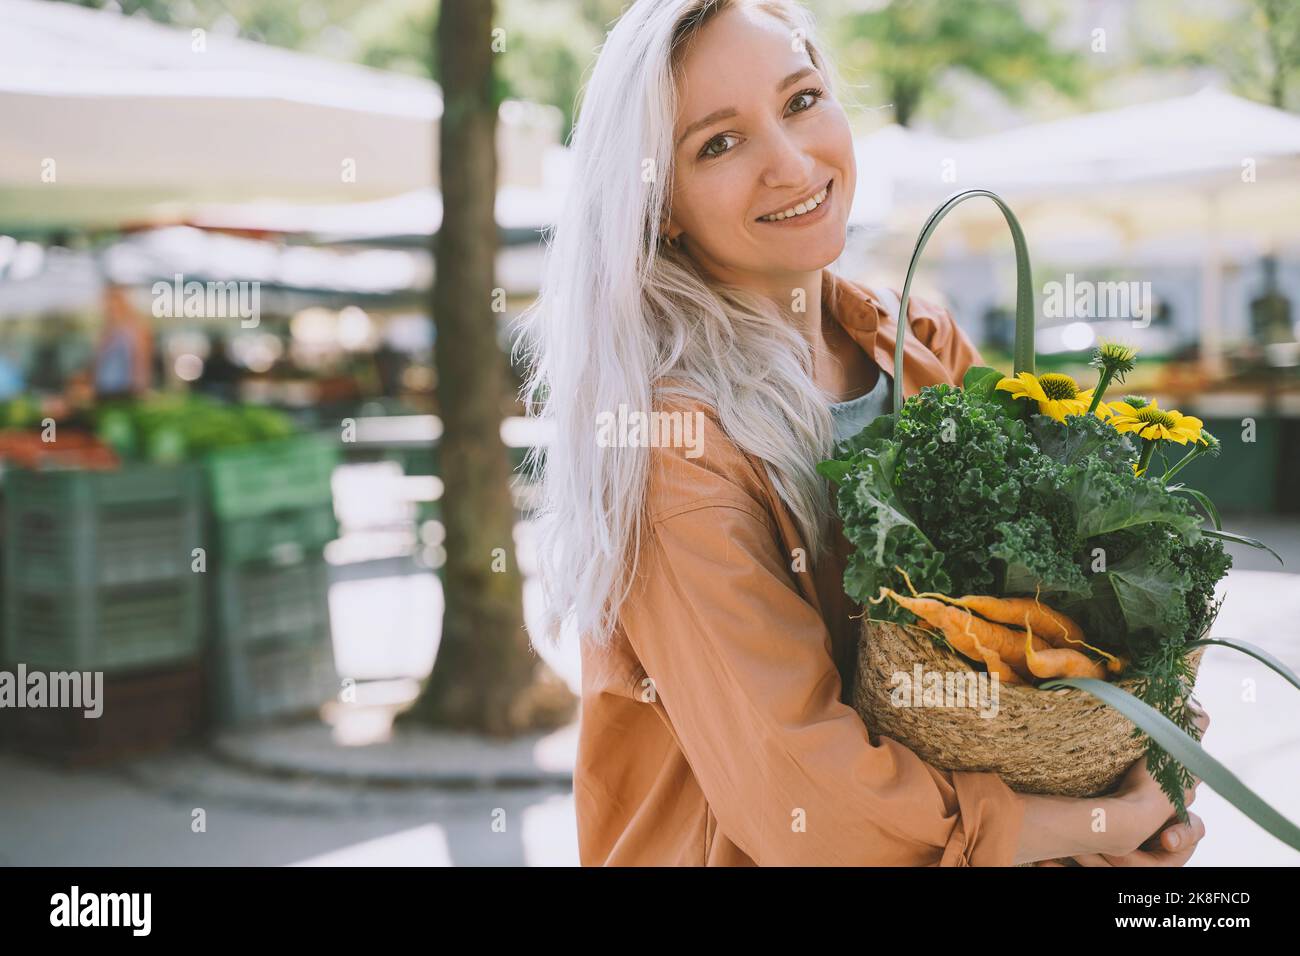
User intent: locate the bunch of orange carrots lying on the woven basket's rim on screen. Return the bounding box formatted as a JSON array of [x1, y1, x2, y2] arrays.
[[871, 568, 1127, 684]]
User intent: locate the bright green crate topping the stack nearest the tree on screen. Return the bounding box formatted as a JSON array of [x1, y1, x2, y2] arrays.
[[204, 434, 342, 520]]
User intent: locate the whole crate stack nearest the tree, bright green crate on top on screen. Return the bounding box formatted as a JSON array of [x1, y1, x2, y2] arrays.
[[205, 436, 339, 727]]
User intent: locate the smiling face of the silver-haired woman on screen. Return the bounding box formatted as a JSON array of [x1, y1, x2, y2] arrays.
[[667, 7, 857, 287]]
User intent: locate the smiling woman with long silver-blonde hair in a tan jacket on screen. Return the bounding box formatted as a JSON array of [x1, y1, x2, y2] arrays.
[[525, 0, 1205, 866]]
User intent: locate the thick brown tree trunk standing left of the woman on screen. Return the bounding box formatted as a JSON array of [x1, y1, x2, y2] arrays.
[[404, 0, 575, 736]]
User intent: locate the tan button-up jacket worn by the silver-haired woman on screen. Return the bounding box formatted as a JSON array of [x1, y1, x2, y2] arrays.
[[573, 271, 1024, 866]]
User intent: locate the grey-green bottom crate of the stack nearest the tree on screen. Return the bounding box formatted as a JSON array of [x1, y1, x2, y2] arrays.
[[209, 631, 338, 728]]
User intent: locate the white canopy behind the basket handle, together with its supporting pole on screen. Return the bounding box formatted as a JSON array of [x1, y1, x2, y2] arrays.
[[857, 88, 1300, 373]]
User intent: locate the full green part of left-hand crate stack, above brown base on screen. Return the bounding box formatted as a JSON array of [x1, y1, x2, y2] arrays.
[[0, 467, 204, 674]]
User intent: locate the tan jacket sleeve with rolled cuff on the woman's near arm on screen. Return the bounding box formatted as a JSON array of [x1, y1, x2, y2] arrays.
[[620, 489, 1024, 866]]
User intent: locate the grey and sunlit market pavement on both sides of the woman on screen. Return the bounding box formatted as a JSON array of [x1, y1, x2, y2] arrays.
[[0, 519, 1300, 866]]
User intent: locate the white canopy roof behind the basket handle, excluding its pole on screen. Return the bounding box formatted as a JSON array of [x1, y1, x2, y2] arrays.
[[857, 88, 1300, 239]]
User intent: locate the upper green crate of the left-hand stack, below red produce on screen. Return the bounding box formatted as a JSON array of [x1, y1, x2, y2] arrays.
[[4, 466, 203, 592]]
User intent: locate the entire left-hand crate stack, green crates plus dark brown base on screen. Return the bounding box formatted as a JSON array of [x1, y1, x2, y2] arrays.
[[0, 466, 204, 762]]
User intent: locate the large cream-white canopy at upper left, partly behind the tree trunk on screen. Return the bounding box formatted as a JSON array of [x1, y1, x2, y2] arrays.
[[0, 0, 558, 232]]
